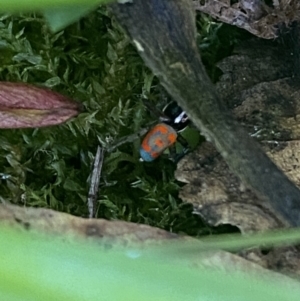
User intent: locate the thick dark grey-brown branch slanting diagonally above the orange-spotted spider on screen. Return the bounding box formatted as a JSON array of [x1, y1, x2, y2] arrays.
[[111, 0, 300, 226]]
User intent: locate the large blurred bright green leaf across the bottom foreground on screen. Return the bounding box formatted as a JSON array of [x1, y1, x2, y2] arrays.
[[0, 226, 300, 301]]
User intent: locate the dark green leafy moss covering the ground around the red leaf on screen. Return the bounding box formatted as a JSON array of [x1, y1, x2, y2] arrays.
[[0, 8, 246, 235]]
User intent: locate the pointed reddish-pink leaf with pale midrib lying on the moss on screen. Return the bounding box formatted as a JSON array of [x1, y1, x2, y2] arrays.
[[0, 82, 80, 129]]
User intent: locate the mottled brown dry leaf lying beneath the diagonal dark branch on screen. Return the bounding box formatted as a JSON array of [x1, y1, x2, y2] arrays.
[[175, 39, 300, 277]]
